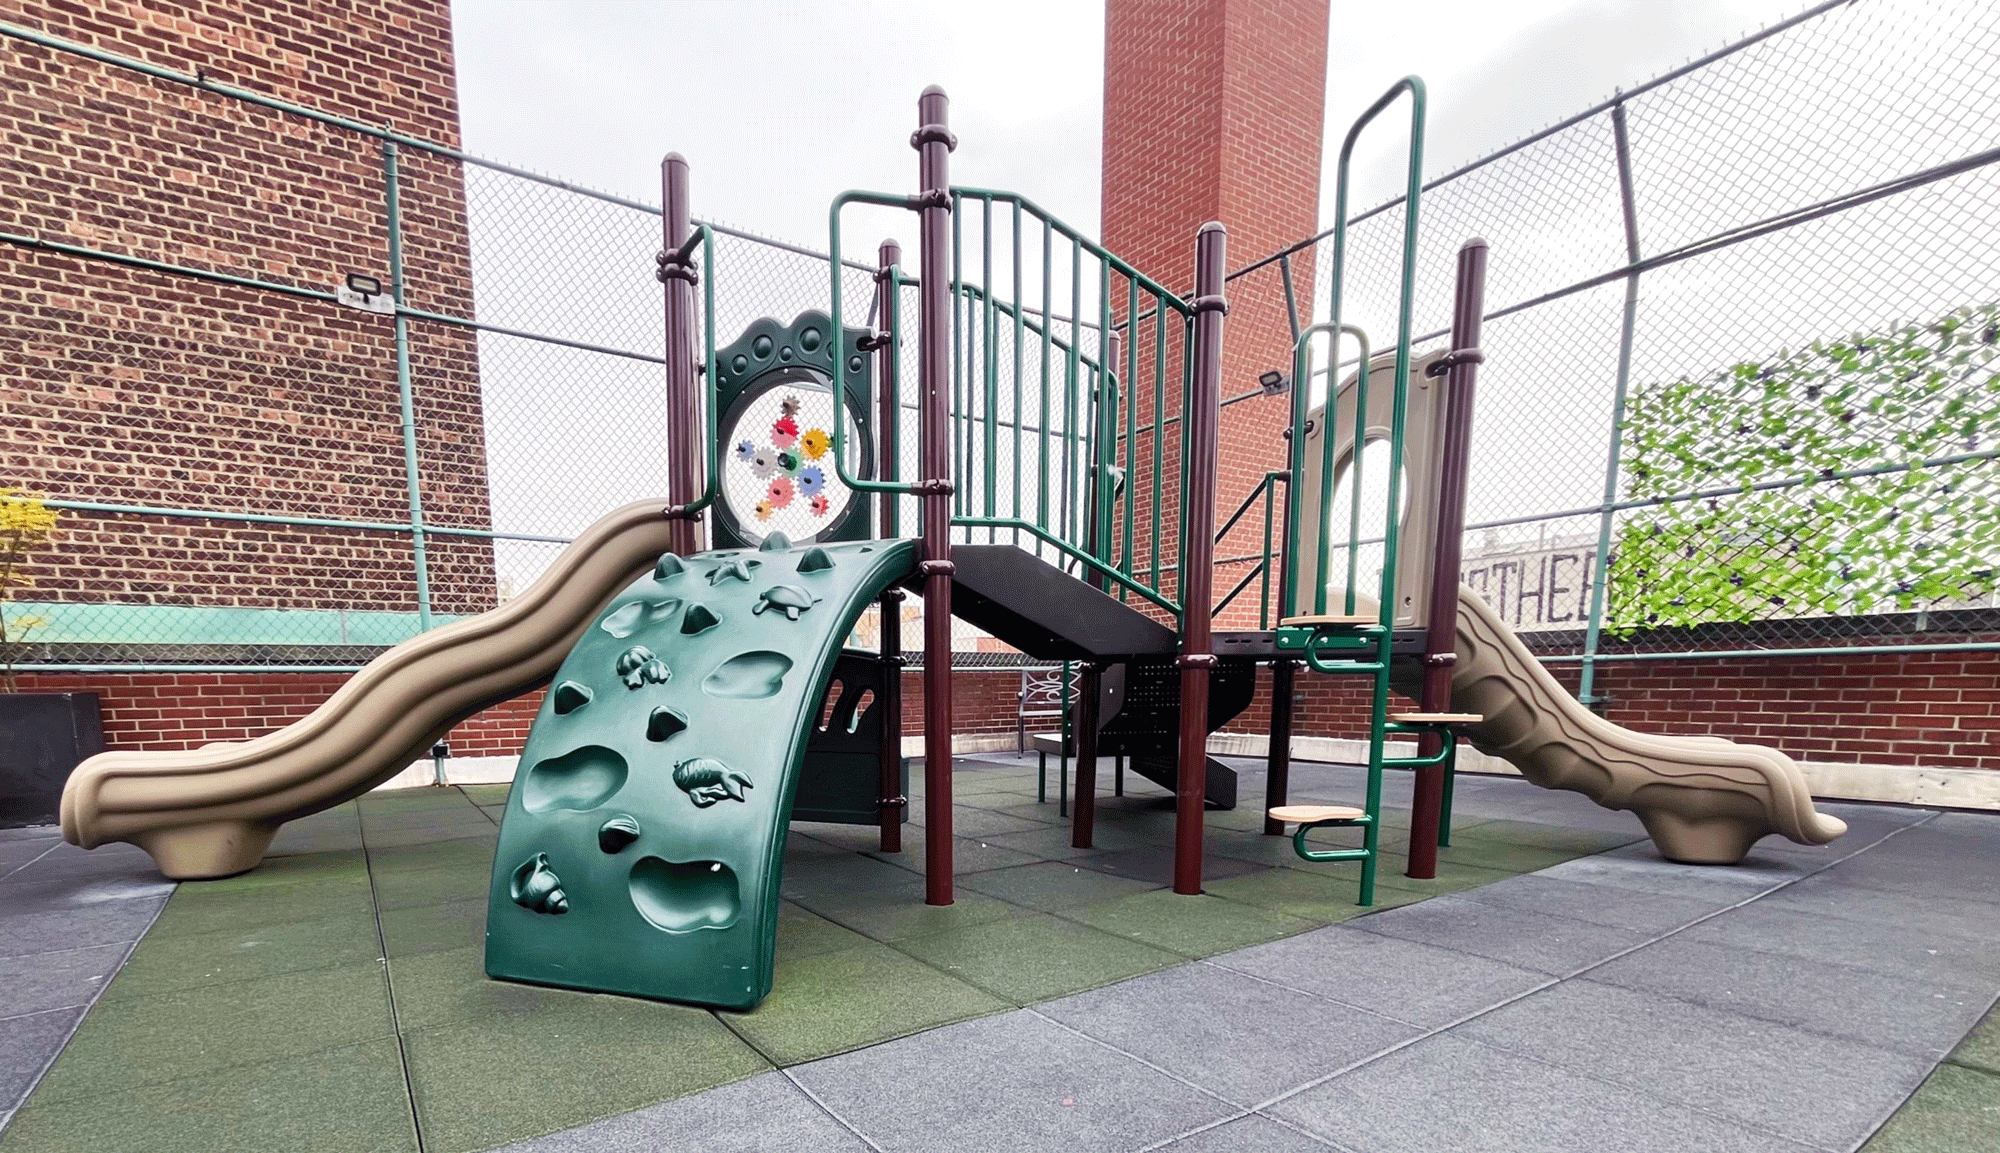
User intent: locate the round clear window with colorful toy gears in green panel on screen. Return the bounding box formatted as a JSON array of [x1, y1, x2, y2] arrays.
[[720, 368, 868, 544]]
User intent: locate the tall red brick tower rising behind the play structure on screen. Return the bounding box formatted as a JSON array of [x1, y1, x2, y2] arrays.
[[1102, 0, 1328, 629]]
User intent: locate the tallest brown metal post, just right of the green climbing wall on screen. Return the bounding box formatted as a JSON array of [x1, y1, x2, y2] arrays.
[[910, 86, 958, 905]]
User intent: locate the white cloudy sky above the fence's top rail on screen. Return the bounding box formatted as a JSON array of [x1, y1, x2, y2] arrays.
[[454, 0, 1806, 256]]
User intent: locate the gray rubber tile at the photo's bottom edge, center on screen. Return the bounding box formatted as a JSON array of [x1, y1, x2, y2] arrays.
[[792, 1013, 1234, 1153]]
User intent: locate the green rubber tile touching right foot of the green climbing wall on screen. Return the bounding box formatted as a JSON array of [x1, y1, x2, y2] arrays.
[[716, 943, 1010, 1065]]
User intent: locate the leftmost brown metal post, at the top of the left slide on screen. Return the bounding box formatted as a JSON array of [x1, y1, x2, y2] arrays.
[[660, 152, 704, 556]]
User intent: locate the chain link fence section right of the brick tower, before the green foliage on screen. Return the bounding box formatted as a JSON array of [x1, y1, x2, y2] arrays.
[[1232, 0, 2000, 693]]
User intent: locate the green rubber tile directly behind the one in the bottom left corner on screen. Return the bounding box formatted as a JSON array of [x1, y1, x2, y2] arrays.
[[34, 961, 392, 1101]]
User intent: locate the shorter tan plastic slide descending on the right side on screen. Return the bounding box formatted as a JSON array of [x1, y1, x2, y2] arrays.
[[1416, 587, 1848, 865]]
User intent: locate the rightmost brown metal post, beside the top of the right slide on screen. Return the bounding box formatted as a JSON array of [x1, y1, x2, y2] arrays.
[[1404, 238, 1486, 879]]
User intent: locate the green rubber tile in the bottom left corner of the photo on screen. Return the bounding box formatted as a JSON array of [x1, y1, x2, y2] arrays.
[[0, 1039, 416, 1153]]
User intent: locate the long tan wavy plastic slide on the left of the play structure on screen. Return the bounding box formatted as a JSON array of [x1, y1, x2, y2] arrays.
[[62, 500, 668, 881]]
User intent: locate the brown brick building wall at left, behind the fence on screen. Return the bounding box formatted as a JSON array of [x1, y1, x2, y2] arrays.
[[0, 0, 494, 620]]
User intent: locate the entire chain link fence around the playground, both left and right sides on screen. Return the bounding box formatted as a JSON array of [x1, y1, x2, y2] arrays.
[[0, 0, 2000, 671]]
